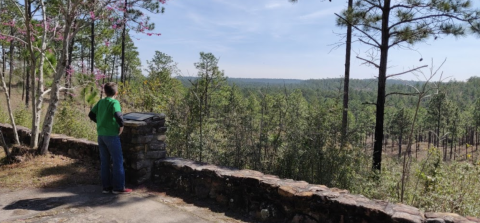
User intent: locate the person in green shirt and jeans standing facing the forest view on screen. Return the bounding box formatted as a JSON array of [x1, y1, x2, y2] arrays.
[[88, 82, 132, 194]]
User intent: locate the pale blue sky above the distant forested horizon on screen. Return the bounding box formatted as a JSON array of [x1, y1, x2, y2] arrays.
[[134, 0, 480, 81]]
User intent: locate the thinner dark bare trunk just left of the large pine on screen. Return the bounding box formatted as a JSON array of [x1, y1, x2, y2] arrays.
[[340, 0, 353, 148]]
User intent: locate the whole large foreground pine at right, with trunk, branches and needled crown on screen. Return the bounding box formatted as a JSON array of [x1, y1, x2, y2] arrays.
[[337, 0, 480, 171]]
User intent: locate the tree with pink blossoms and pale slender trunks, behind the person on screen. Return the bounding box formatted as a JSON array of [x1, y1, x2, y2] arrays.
[[0, 0, 169, 154]]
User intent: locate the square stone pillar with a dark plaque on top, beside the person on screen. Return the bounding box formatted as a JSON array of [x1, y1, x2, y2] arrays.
[[120, 113, 167, 185]]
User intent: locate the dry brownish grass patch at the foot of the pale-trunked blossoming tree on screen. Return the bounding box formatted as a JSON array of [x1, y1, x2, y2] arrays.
[[0, 147, 100, 190]]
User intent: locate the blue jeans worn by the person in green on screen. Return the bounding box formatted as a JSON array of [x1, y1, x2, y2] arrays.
[[98, 136, 125, 190]]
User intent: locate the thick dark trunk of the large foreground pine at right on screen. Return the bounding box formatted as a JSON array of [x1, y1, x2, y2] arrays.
[[372, 0, 390, 172]]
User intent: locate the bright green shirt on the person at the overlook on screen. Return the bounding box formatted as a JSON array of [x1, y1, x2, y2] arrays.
[[92, 97, 122, 136]]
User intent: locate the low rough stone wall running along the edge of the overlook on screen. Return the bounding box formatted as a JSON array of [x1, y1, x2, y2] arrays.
[[0, 123, 480, 223]]
